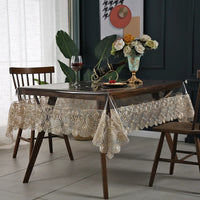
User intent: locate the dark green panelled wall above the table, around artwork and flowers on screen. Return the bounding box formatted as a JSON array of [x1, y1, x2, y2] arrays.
[[80, 0, 200, 80]]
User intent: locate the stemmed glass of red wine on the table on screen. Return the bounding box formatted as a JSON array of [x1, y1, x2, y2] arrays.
[[71, 55, 83, 87]]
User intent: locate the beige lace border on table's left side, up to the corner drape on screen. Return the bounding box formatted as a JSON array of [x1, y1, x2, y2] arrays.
[[6, 98, 99, 138]]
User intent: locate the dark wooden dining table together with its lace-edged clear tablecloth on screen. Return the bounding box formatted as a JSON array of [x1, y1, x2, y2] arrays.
[[7, 80, 194, 199]]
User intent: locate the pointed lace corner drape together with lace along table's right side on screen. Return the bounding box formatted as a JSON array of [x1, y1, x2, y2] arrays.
[[93, 94, 194, 158]]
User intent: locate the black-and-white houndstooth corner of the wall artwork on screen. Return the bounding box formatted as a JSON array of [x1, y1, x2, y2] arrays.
[[102, 0, 124, 20]]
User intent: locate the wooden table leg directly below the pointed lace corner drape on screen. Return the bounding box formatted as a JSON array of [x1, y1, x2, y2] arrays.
[[101, 153, 109, 199]]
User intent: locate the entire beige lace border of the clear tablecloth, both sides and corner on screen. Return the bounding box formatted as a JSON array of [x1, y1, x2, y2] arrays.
[[6, 94, 194, 158]]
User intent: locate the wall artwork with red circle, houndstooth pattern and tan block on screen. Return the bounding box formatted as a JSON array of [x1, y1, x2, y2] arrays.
[[99, 0, 144, 39]]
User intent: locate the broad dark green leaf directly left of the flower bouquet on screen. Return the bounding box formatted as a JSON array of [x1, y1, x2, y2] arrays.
[[95, 35, 117, 60]]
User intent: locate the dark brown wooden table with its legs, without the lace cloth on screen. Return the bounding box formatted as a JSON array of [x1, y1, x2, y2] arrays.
[[17, 80, 191, 199]]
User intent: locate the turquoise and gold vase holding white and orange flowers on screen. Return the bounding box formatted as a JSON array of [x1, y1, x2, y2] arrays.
[[111, 34, 158, 84]]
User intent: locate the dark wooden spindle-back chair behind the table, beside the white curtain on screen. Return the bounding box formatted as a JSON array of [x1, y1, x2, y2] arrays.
[[10, 67, 73, 160]]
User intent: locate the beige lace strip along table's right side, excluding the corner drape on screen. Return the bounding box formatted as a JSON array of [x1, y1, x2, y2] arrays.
[[117, 94, 194, 132]]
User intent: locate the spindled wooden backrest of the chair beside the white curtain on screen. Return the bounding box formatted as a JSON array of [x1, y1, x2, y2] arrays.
[[10, 66, 54, 99]]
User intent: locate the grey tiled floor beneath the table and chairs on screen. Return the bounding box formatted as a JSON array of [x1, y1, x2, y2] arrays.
[[0, 137, 200, 200]]
